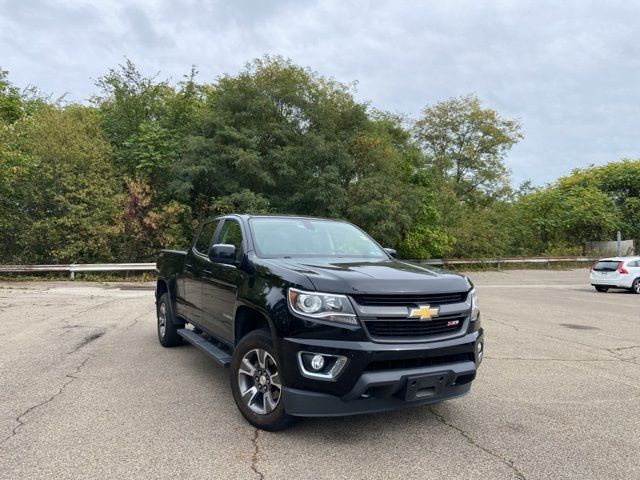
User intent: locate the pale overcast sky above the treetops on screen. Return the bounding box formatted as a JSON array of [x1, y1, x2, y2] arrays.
[[0, 0, 640, 184]]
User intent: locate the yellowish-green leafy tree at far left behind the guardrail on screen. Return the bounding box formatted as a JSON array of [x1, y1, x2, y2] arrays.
[[0, 105, 117, 263]]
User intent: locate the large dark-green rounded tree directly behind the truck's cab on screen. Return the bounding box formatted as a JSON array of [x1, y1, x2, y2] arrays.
[[174, 57, 432, 245]]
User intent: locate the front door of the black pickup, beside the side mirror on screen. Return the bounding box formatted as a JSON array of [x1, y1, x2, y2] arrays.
[[202, 218, 246, 342]]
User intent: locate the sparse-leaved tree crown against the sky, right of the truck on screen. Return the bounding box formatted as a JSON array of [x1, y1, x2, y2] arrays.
[[413, 96, 522, 205]]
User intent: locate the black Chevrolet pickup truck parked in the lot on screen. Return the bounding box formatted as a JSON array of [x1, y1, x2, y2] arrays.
[[156, 215, 483, 430]]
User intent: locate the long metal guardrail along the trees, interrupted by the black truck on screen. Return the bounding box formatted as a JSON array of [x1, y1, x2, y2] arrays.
[[0, 257, 595, 278]]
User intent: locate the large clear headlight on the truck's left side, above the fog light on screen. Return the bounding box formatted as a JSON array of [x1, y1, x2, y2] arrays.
[[289, 288, 358, 325]]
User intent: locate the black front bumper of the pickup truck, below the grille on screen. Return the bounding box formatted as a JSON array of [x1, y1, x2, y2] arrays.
[[280, 330, 484, 417]]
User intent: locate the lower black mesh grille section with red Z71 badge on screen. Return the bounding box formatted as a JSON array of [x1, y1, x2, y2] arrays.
[[364, 315, 466, 338]]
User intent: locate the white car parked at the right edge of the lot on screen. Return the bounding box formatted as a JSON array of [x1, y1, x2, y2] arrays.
[[589, 257, 640, 293]]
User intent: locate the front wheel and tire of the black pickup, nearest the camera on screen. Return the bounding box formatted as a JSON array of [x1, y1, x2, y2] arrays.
[[230, 329, 295, 432]]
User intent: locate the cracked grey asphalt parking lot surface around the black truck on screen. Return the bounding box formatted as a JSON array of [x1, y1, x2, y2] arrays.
[[0, 269, 640, 480]]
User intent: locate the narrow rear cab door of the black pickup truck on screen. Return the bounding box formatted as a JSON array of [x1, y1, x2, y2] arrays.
[[184, 220, 220, 324]]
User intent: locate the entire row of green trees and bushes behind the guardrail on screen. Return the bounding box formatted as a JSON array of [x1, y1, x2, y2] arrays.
[[0, 61, 640, 263]]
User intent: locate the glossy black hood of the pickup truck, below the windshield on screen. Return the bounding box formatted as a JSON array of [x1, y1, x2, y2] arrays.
[[268, 258, 472, 294]]
